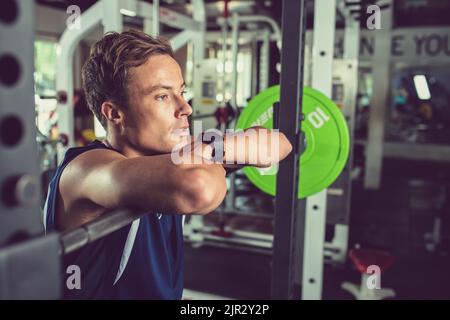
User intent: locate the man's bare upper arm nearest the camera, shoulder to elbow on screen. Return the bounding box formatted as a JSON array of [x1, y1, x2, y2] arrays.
[[60, 150, 226, 218]]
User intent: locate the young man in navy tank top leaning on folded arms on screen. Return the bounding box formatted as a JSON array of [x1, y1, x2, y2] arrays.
[[45, 30, 291, 299]]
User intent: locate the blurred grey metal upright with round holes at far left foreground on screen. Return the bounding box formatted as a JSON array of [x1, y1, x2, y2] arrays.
[[0, 1, 61, 299]]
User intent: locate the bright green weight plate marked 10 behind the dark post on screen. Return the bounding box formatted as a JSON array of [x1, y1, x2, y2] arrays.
[[236, 85, 350, 198]]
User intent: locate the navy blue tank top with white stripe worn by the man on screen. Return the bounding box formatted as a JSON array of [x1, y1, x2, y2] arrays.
[[44, 140, 184, 299]]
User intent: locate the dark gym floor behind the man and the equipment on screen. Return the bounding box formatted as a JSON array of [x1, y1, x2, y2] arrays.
[[185, 160, 450, 300]]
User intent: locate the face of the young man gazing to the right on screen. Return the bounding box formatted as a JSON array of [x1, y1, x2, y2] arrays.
[[123, 55, 192, 155]]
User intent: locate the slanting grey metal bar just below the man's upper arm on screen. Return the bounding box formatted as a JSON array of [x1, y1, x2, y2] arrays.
[[61, 210, 146, 254]]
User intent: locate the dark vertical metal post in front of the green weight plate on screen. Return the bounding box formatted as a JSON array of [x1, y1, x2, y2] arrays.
[[271, 0, 306, 299]]
